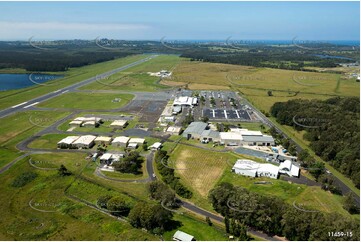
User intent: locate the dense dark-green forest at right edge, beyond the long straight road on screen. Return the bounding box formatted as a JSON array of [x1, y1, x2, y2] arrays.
[[271, 97, 360, 188]]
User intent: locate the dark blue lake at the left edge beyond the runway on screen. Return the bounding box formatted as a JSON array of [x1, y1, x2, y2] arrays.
[[0, 74, 64, 91]]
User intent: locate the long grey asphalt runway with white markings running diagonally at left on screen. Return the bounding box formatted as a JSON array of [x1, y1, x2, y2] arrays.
[[0, 55, 157, 118]]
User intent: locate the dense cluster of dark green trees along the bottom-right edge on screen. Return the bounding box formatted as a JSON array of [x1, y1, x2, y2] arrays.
[[209, 183, 360, 241]]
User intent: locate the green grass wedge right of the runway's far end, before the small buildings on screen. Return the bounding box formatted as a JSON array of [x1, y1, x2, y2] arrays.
[[80, 55, 180, 92]]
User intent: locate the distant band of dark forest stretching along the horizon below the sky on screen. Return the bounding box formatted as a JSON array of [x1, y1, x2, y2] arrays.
[[0, 39, 359, 71]]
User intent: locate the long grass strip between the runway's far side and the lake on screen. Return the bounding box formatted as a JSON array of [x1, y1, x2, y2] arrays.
[[0, 55, 146, 109]]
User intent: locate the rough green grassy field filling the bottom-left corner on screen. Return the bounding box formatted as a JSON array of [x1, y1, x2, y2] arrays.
[[0, 154, 159, 240]]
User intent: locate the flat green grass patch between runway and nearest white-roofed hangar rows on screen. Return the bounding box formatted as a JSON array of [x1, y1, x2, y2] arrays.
[[37, 93, 134, 110]]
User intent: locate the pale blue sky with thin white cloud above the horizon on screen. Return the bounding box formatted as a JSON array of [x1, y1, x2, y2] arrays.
[[0, 2, 360, 40]]
